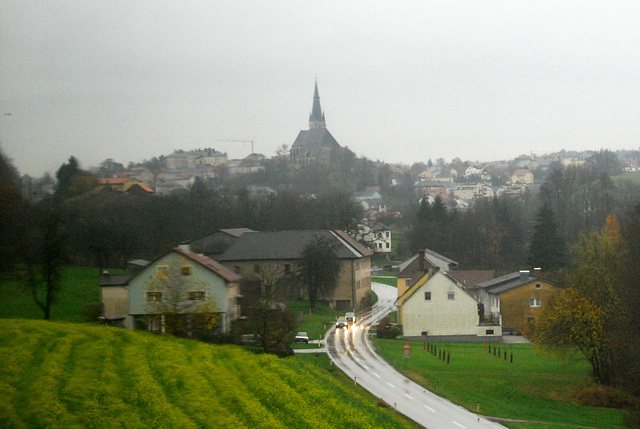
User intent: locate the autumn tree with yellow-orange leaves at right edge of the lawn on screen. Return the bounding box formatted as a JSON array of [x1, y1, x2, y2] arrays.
[[535, 216, 627, 386]]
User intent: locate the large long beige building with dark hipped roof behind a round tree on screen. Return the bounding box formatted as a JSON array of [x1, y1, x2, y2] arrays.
[[218, 230, 373, 311]]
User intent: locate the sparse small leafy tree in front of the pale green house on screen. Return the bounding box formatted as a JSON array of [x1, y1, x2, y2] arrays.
[[146, 259, 219, 338]]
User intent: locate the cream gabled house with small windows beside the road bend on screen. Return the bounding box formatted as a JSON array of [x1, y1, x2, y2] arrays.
[[396, 271, 502, 340]]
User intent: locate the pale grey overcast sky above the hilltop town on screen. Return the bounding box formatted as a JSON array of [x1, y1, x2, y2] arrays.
[[0, 0, 640, 176]]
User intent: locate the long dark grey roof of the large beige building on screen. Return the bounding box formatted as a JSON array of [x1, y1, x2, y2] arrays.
[[218, 230, 373, 262]]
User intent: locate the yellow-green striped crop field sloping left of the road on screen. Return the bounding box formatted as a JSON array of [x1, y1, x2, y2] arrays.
[[0, 319, 409, 428]]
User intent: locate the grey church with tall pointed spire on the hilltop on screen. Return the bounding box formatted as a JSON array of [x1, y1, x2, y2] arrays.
[[290, 81, 340, 167]]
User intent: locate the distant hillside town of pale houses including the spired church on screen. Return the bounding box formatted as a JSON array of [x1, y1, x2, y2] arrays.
[[17, 82, 640, 254]]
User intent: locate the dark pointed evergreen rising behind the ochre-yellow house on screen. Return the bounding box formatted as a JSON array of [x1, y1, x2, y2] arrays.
[[528, 203, 567, 270]]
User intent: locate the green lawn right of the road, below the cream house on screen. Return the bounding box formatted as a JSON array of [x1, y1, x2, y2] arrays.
[[375, 339, 624, 429]]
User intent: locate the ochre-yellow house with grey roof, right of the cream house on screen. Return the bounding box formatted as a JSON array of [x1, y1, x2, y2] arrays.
[[470, 270, 562, 335]]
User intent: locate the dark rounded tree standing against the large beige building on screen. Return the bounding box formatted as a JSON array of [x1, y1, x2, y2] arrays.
[[298, 237, 340, 311]]
